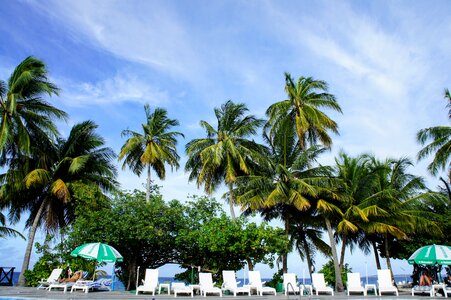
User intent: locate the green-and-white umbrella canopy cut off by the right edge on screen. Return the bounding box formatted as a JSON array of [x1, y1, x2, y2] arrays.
[[407, 245, 451, 265]]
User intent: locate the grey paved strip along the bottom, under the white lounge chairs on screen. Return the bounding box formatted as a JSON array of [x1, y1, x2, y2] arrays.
[[0, 287, 444, 300]]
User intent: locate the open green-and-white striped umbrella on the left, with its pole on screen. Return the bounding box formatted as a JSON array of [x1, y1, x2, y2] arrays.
[[70, 243, 123, 290]]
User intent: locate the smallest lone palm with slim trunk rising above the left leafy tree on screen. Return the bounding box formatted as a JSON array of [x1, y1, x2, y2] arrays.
[[118, 104, 184, 201]]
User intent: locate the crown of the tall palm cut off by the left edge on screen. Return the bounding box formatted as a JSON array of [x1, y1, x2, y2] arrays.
[[0, 56, 67, 159]]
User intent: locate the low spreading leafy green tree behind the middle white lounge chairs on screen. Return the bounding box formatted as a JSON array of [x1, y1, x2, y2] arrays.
[[177, 197, 286, 278]]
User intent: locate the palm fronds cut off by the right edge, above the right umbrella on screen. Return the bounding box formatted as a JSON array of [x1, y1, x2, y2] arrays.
[[417, 89, 451, 180]]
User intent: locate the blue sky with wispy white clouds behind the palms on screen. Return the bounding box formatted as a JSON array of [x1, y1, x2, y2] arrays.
[[0, 0, 451, 277]]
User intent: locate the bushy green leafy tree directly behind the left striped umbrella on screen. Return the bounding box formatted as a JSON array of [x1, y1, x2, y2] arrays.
[[69, 189, 186, 290]]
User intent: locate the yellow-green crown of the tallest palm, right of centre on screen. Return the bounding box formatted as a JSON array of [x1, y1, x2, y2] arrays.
[[266, 73, 341, 149]]
